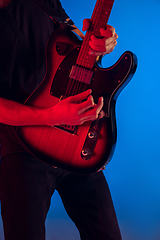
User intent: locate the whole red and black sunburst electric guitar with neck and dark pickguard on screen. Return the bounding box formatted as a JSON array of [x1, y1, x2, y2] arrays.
[[15, 0, 137, 173]]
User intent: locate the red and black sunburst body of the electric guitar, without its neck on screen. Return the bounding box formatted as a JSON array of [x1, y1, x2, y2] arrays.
[[16, 28, 136, 173]]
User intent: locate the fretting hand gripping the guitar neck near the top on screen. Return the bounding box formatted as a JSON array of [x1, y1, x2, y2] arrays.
[[82, 19, 118, 56]]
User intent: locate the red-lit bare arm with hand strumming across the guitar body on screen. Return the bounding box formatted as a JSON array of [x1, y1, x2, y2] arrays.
[[0, 89, 103, 126]]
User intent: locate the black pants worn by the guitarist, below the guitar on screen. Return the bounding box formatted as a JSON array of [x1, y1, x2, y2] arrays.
[[1, 153, 121, 240]]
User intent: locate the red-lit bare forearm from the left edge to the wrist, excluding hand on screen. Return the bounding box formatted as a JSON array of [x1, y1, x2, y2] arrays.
[[0, 98, 46, 126]]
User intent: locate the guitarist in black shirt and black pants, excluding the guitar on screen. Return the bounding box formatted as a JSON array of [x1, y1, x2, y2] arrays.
[[0, 0, 121, 240]]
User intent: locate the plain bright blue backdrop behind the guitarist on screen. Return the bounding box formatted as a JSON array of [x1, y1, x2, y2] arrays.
[[0, 0, 160, 240]]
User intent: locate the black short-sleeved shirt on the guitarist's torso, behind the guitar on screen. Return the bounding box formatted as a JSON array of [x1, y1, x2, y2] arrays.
[[0, 0, 68, 103]]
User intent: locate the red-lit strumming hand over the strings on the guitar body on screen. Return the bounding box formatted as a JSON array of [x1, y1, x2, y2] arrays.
[[45, 90, 103, 126]]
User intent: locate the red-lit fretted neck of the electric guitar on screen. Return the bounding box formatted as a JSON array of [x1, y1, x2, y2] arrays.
[[76, 0, 114, 69]]
